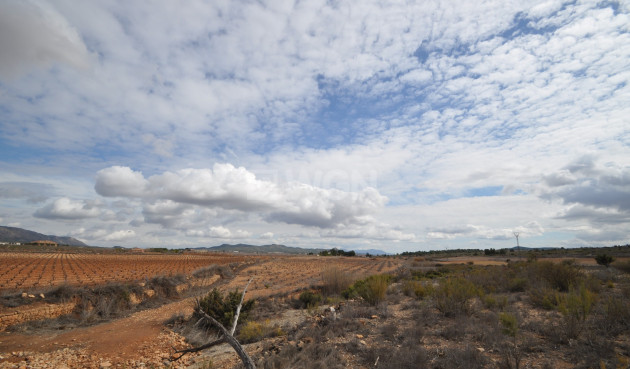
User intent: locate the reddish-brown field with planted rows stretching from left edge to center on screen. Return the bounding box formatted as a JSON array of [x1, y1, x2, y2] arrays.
[[0, 252, 399, 295]]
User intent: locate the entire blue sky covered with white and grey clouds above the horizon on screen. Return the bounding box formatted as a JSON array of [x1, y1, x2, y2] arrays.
[[0, 0, 630, 253]]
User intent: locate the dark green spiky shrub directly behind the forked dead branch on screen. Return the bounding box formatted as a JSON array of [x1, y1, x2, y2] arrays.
[[198, 288, 255, 329]]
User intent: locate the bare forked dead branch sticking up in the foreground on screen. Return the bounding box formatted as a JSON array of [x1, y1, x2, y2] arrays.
[[170, 278, 256, 369]]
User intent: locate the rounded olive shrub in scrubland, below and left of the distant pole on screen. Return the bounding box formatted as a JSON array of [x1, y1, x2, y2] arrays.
[[433, 277, 480, 316]]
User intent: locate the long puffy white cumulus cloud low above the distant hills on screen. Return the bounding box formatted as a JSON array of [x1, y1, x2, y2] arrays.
[[95, 164, 387, 228]]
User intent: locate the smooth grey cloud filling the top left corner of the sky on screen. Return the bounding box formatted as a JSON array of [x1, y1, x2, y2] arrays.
[[0, 0, 88, 77]]
